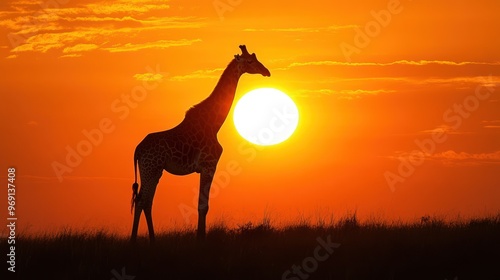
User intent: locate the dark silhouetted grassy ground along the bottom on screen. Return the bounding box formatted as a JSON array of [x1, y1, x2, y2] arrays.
[[1, 214, 500, 280]]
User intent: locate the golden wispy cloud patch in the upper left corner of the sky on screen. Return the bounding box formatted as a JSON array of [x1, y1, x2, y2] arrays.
[[0, 0, 205, 58]]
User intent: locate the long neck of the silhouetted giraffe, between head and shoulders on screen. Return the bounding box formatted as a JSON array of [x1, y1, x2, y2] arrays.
[[186, 59, 241, 133]]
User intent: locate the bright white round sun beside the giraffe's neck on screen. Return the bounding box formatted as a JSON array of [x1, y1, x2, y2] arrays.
[[233, 88, 299, 146]]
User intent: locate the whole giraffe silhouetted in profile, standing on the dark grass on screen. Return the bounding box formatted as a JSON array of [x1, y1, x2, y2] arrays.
[[131, 45, 271, 241]]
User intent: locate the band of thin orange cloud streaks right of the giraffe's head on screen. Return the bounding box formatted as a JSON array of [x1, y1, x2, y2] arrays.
[[280, 60, 500, 92]]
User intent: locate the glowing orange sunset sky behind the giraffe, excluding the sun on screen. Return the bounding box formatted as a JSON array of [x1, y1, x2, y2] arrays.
[[0, 0, 500, 234]]
